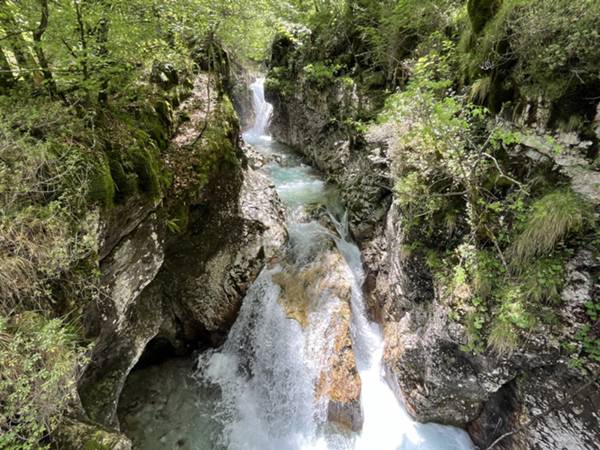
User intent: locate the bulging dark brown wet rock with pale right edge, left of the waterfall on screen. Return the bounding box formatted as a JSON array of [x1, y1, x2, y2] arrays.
[[160, 163, 287, 340]]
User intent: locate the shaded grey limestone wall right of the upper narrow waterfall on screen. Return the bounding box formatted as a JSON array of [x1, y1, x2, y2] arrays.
[[265, 65, 391, 240]]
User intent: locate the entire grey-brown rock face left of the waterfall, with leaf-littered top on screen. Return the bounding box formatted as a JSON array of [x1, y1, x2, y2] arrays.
[[76, 72, 287, 438]]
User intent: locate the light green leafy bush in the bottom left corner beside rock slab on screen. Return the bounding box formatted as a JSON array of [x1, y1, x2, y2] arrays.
[[0, 313, 85, 449]]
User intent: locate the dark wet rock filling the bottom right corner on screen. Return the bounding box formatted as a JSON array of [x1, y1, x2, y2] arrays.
[[468, 366, 600, 450]]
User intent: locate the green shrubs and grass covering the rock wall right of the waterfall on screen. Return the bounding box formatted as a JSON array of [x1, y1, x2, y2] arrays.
[[379, 30, 593, 354]]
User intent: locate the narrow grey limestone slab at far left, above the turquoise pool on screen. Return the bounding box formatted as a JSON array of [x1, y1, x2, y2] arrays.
[[79, 214, 165, 428]]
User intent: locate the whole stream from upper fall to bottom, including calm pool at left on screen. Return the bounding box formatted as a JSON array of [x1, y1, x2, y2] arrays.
[[121, 80, 473, 450]]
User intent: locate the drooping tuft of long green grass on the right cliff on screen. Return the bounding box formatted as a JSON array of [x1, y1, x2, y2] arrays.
[[510, 189, 593, 267]]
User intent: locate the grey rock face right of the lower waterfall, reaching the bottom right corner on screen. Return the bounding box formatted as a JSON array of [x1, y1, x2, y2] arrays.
[[375, 201, 600, 442]]
